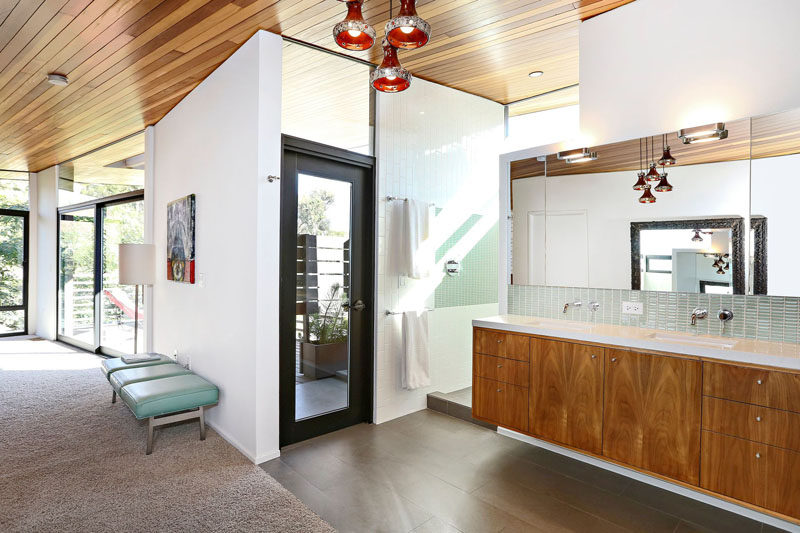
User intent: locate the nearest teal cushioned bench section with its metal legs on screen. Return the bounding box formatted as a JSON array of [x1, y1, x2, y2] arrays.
[[117, 372, 219, 455]]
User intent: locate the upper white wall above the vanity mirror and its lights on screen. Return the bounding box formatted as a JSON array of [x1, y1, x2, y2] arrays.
[[579, 0, 800, 145]]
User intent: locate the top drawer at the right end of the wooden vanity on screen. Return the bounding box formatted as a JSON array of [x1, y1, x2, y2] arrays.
[[703, 362, 800, 412]]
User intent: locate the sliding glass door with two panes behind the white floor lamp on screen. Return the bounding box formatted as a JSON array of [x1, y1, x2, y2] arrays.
[[58, 191, 144, 355]]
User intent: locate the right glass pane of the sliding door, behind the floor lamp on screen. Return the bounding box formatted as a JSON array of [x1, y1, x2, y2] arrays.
[[100, 200, 144, 353]]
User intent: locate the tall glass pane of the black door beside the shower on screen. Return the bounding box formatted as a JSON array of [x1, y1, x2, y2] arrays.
[[295, 174, 352, 420]]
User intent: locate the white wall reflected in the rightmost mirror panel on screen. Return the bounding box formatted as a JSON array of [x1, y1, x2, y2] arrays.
[[752, 154, 800, 296]]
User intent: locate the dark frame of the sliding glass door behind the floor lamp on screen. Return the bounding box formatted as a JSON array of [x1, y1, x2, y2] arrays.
[[56, 189, 144, 357]]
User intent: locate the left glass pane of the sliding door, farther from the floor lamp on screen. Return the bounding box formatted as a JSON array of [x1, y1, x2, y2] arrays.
[[58, 207, 96, 348]]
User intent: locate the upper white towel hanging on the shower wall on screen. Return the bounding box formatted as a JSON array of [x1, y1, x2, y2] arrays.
[[400, 198, 435, 279]]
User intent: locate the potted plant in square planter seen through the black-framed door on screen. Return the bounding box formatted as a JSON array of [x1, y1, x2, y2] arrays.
[[301, 283, 348, 379]]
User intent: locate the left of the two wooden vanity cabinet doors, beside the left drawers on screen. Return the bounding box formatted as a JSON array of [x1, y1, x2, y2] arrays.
[[529, 339, 605, 455]]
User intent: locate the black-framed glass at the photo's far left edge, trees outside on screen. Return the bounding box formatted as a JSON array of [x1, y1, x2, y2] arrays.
[[0, 209, 28, 337]]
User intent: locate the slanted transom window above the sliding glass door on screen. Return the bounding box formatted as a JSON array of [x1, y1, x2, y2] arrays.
[[59, 132, 144, 188]]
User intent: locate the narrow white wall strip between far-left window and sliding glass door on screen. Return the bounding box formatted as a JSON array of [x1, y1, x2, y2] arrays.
[[34, 166, 58, 340]]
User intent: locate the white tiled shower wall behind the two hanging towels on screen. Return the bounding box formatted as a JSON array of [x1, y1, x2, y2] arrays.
[[375, 79, 503, 423]]
